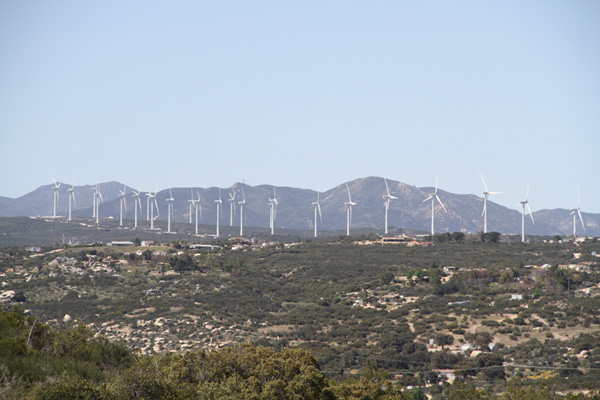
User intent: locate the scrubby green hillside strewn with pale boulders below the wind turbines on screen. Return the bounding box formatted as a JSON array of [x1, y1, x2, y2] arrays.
[[0, 235, 600, 399]]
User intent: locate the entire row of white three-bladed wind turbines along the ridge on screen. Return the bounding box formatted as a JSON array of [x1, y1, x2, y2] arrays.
[[53, 173, 585, 242]]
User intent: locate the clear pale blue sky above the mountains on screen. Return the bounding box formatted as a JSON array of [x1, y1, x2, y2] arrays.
[[0, 0, 600, 213]]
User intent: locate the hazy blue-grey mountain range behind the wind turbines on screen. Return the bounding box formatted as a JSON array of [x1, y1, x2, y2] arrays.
[[0, 177, 600, 236]]
